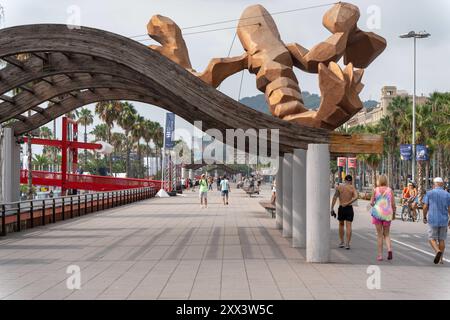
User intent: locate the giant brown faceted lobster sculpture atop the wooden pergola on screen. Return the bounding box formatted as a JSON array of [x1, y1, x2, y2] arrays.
[[147, 2, 386, 129]]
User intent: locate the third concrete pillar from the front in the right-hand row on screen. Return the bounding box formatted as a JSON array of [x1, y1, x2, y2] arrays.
[[283, 153, 292, 237]]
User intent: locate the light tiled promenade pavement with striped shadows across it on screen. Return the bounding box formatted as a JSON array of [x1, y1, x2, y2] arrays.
[[0, 185, 450, 299]]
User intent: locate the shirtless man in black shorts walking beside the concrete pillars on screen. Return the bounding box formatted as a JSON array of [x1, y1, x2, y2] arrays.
[[331, 175, 358, 250]]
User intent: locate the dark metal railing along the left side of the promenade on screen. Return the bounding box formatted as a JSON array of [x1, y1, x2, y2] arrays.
[[0, 187, 157, 236]]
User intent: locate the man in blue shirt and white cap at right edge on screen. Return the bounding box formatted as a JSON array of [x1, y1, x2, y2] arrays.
[[423, 177, 450, 264]]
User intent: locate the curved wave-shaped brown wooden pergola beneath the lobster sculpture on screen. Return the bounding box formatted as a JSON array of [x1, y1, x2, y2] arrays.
[[0, 24, 382, 154]]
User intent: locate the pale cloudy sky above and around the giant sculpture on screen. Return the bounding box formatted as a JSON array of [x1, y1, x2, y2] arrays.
[[0, 0, 450, 142]]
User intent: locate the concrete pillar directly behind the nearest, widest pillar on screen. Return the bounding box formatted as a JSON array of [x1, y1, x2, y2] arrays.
[[292, 149, 306, 248]]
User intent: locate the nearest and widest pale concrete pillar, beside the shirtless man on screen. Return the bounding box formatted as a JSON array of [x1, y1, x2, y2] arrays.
[[306, 144, 330, 263]]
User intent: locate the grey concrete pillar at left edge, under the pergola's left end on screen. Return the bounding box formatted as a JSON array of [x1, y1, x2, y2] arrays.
[[0, 128, 20, 202]]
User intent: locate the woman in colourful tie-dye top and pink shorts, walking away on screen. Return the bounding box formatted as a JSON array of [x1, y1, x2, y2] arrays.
[[370, 175, 396, 261]]
